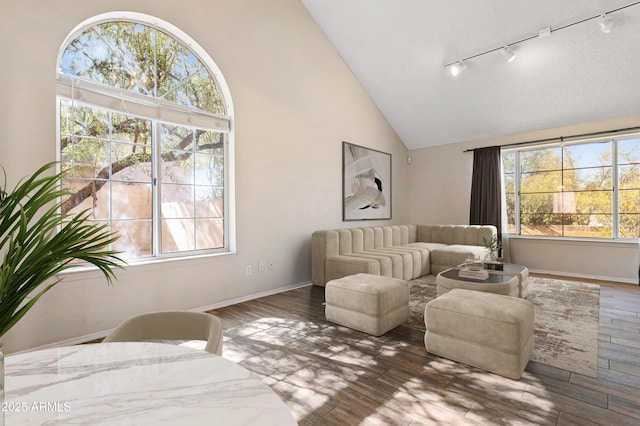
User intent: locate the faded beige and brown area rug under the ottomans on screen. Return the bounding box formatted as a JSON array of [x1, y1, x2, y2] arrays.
[[406, 275, 600, 377]]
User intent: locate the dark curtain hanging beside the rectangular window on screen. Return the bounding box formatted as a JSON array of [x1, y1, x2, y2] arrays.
[[469, 146, 502, 238]]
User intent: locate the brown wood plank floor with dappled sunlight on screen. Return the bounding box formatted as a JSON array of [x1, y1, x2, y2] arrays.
[[210, 276, 640, 426]]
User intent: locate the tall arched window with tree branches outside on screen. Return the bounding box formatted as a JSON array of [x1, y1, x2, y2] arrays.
[[57, 15, 231, 259]]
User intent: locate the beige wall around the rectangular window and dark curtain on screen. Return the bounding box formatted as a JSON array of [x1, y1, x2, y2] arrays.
[[409, 116, 640, 284]]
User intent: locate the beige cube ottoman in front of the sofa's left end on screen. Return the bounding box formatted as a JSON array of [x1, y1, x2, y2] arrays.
[[325, 274, 409, 336]]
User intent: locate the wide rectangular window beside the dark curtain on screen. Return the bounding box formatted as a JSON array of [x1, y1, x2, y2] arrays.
[[502, 136, 640, 239]]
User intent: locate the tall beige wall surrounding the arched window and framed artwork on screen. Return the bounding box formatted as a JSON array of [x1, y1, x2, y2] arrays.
[[0, 0, 409, 353]]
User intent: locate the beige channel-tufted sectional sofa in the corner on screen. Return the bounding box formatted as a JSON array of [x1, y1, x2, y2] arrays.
[[311, 225, 497, 286]]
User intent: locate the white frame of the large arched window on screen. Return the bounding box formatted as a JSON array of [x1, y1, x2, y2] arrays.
[[56, 12, 236, 263]]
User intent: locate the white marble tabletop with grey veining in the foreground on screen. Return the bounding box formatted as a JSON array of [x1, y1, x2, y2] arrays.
[[3, 343, 296, 426]]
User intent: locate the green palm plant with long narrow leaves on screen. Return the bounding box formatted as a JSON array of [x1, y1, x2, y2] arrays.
[[0, 163, 124, 337]]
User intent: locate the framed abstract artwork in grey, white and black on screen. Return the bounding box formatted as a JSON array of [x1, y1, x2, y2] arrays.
[[342, 142, 391, 221]]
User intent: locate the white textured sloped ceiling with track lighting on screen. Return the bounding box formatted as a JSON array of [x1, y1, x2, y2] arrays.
[[301, 0, 640, 149]]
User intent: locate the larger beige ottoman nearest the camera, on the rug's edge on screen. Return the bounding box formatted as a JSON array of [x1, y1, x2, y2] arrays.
[[424, 288, 533, 379]]
